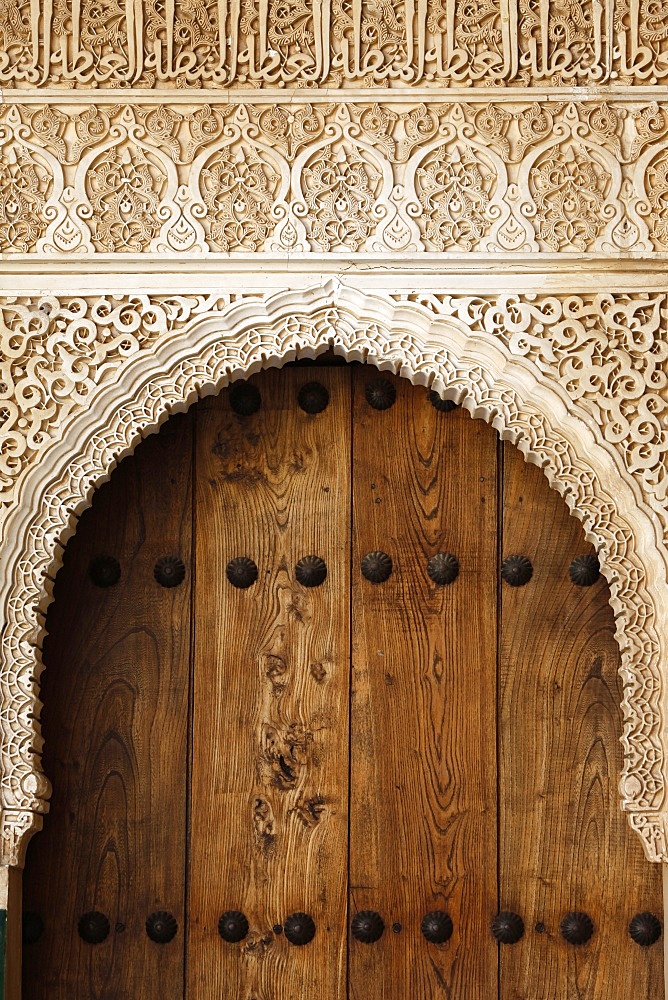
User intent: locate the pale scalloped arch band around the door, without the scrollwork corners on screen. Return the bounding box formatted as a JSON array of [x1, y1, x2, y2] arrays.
[[0, 280, 668, 866]]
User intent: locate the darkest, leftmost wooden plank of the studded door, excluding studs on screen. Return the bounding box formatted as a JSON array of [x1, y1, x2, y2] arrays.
[[23, 416, 192, 1000]]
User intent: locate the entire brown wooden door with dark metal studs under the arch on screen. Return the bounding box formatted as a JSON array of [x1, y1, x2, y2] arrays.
[[24, 366, 663, 1000]]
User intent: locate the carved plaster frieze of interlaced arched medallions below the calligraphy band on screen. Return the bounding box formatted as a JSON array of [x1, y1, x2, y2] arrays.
[[0, 100, 668, 258]]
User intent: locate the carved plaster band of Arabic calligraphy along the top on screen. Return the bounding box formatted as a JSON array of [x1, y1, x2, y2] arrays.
[[0, 0, 668, 88]]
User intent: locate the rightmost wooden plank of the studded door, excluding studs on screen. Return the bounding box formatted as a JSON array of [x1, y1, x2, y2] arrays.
[[499, 445, 663, 1000]]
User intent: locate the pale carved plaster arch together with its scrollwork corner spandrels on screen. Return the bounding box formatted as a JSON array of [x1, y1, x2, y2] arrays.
[[0, 280, 668, 864]]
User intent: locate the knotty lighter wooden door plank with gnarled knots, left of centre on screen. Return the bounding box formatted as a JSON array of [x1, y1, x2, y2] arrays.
[[188, 368, 350, 1000]]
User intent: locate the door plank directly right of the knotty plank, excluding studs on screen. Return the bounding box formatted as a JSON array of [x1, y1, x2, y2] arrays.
[[349, 369, 497, 1000]]
